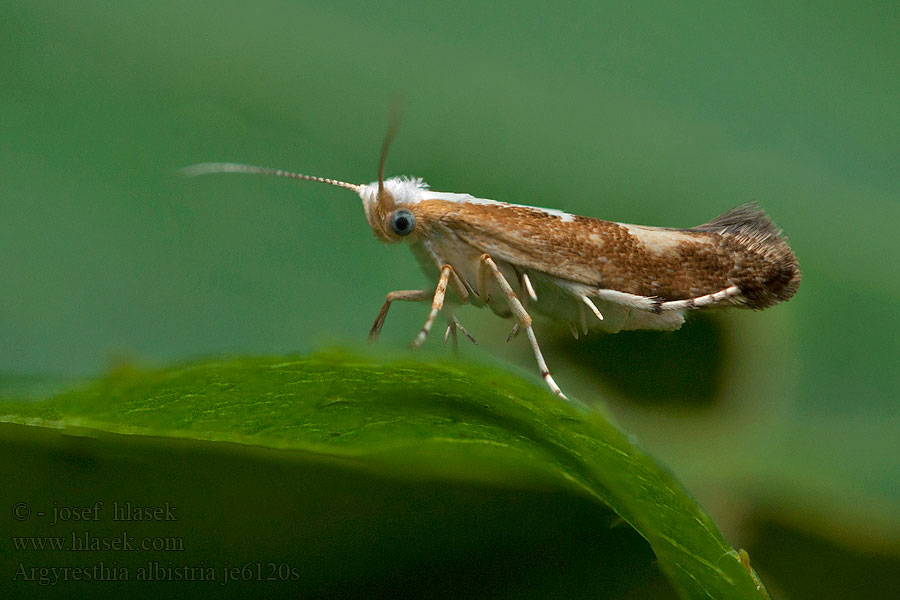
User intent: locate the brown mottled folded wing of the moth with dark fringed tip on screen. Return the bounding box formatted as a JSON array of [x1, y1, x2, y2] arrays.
[[418, 199, 800, 308]]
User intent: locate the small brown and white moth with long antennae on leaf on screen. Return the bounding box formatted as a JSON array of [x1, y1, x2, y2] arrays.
[[184, 132, 800, 398]]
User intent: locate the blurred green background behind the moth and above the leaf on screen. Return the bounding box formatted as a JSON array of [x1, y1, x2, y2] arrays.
[[0, 0, 900, 598]]
